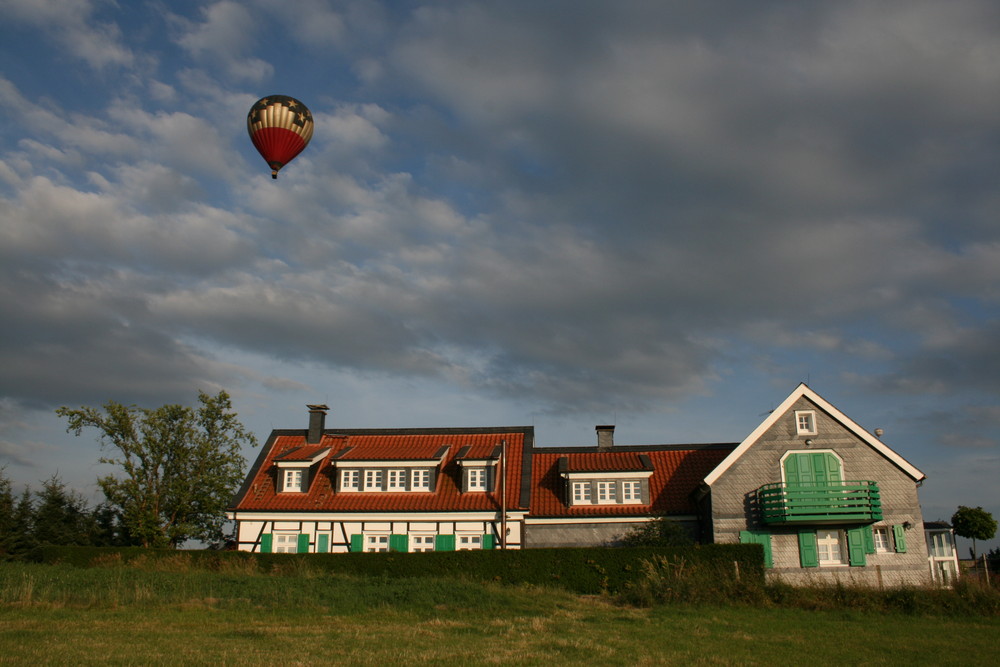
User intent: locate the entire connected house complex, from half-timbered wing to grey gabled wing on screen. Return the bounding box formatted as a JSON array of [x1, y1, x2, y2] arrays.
[[229, 384, 932, 585]]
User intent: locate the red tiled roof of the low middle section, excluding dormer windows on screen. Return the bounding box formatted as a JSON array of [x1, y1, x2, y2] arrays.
[[531, 445, 735, 517]]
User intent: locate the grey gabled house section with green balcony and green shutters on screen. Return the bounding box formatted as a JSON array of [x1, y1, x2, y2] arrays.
[[699, 384, 929, 586]]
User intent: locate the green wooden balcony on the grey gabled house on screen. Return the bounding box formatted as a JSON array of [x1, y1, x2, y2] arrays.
[[757, 480, 882, 524]]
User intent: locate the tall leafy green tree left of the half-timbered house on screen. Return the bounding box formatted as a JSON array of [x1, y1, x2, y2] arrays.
[[56, 391, 257, 547]]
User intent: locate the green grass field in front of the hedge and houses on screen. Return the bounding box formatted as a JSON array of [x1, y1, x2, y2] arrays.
[[0, 563, 1000, 665]]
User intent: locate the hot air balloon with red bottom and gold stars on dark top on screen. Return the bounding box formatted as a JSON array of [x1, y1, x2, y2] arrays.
[[247, 95, 313, 178]]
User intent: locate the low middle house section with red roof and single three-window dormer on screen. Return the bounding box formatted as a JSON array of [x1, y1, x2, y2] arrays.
[[525, 425, 736, 547]]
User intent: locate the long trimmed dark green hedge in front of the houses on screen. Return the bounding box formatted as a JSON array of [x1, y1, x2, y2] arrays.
[[25, 544, 764, 594]]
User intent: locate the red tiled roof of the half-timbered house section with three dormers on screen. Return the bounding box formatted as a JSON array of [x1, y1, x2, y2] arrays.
[[233, 427, 533, 512]]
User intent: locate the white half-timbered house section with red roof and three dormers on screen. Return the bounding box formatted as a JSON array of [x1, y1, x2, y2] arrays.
[[229, 405, 534, 553]]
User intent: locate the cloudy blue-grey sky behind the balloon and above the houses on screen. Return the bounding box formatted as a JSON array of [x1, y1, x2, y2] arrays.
[[0, 0, 1000, 555]]
